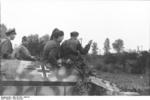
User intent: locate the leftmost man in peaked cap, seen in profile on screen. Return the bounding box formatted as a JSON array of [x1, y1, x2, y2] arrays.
[[0, 29, 16, 59]]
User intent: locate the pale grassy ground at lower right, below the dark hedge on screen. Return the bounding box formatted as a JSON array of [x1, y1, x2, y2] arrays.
[[97, 71, 150, 95]]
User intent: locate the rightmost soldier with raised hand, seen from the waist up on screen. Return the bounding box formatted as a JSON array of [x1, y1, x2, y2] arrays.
[[61, 31, 92, 58]]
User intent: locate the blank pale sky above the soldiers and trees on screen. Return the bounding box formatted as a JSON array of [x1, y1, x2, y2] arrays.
[[1, 0, 150, 52]]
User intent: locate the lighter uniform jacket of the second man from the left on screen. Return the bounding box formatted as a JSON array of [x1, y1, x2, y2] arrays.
[[13, 45, 35, 60]]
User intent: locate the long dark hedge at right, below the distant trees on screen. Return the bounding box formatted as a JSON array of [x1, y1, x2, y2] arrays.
[[87, 51, 150, 74]]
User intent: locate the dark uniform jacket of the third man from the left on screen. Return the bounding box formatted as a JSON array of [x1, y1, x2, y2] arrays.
[[43, 40, 60, 66]]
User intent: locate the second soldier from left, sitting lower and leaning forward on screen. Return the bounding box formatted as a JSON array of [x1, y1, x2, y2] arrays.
[[13, 36, 36, 61]]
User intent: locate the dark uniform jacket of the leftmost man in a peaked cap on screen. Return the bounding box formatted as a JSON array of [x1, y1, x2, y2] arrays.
[[0, 38, 13, 59]]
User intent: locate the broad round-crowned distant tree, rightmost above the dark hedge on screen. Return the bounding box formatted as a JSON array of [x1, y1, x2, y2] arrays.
[[112, 39, 124, 53]]
